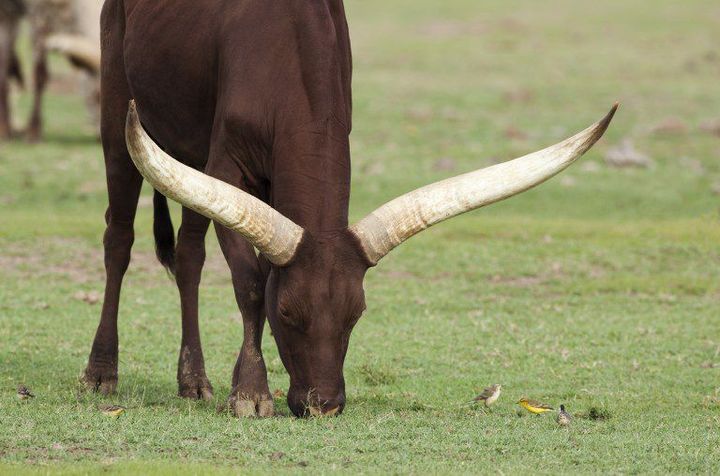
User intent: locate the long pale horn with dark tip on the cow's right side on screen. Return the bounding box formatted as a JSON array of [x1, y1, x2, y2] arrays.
[[350, 104, 618, 264]]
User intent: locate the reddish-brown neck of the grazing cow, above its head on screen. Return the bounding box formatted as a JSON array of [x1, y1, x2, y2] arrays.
[[266, 0, 352, 234]]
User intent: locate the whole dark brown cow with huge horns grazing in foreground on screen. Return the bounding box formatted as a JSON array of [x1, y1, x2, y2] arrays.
[[85, 0, 615, 416]]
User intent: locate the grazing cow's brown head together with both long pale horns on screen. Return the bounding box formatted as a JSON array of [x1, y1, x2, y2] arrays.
[[126, 103, 617, 416]]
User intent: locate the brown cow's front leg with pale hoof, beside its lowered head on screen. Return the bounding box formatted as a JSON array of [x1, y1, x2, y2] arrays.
[[215, 225, 275, 417]]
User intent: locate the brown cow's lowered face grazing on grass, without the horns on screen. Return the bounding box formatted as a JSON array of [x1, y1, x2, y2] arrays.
[[265, 230, 369, 416]]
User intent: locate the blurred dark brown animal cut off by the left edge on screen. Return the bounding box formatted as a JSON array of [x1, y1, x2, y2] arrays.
[[0, 0, 25, 139]]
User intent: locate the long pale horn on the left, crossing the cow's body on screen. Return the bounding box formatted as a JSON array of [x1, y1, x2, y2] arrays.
[[125, 101, 304, 266]]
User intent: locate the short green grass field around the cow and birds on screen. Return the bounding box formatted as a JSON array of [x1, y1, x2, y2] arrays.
[[0, 0, 720, 474]]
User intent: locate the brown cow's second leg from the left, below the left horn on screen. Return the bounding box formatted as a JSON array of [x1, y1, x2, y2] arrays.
[[175, 208, 212, 400]]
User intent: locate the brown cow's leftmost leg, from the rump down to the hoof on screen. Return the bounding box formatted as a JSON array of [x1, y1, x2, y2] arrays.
[[84, 3, 142, 394]]
